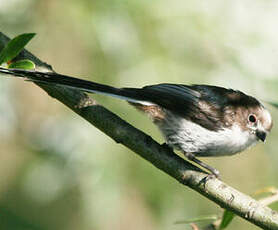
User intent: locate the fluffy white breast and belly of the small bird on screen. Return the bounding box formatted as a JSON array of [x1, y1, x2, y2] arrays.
[[157, 112, 257, 156]]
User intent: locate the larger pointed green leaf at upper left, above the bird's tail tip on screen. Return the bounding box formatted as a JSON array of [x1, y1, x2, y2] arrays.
[[0, 33, 36, 65]]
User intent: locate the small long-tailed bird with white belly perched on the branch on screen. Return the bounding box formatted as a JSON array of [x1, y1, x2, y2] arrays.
[[0, 67, 273, 177]]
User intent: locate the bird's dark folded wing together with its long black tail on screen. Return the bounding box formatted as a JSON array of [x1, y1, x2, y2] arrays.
[[0, 67, 230, 131]]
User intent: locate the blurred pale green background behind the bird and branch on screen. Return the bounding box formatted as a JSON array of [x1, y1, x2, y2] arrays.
[[0, 0, 278, 230]]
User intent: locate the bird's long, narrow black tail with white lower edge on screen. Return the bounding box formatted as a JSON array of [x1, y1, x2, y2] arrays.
[[0, 67, 152, 104]]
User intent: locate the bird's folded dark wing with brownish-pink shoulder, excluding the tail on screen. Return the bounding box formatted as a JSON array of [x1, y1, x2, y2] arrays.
[[124, 84, 229, 131]]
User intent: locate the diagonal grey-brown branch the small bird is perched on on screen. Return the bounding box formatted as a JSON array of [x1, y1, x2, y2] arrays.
[[0, 32, 278, 229]]
